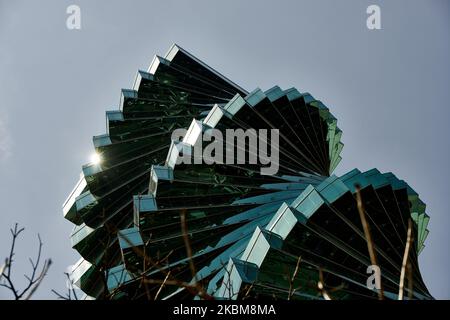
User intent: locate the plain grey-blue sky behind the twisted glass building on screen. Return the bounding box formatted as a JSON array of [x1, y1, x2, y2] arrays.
[[0, 0, 450, 298]]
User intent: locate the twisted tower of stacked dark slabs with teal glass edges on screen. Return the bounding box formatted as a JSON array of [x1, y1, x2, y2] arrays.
[[63, 45, 431, 299]]
